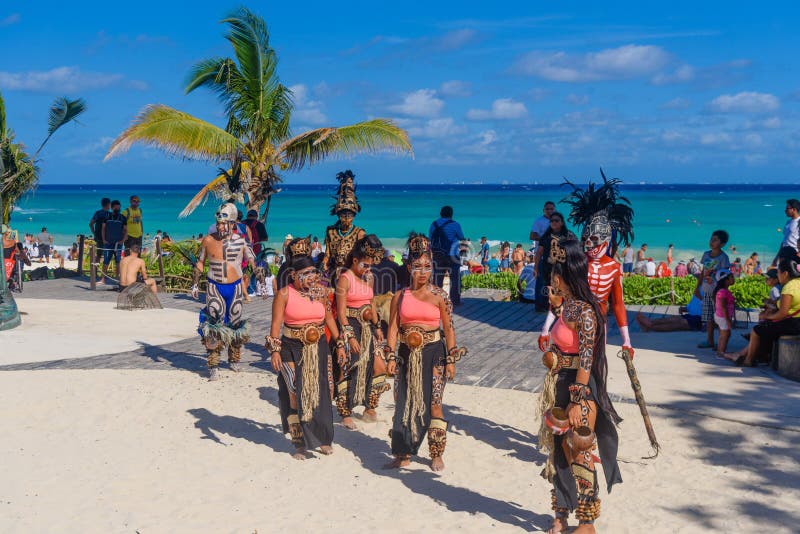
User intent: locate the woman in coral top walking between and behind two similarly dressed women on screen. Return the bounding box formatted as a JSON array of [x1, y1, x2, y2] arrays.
[[336, 234, 390, 429]]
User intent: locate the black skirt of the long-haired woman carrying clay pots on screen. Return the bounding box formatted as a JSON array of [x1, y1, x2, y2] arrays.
[[553, 369, 622, 510]]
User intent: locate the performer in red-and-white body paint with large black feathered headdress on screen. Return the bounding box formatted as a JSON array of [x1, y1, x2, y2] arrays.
[[539, 169, 633, 355]]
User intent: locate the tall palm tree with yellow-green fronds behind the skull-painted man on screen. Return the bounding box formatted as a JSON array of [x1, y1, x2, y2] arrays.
[[105, 8, 412, 220]]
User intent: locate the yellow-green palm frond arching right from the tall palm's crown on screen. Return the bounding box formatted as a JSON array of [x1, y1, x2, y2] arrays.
[[277, 119, 414, 170]]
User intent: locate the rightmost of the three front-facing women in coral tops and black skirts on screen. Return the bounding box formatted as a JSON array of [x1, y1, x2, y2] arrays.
[[386, 235, 466, 471]]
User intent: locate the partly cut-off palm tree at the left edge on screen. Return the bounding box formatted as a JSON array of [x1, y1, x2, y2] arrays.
[[0, 94, 86, 224]]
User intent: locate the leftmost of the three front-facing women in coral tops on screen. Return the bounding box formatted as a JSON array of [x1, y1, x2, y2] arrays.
[[266, 254, 345, 460]]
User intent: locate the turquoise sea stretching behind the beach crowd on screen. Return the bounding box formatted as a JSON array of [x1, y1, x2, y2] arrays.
[[11, 184, 800, 261]]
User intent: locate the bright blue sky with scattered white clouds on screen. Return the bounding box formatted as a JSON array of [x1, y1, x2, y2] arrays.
[[0, 0, 800, 184]]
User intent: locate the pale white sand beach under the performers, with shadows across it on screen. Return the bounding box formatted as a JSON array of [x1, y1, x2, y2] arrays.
[[0, 298, 800, 534]]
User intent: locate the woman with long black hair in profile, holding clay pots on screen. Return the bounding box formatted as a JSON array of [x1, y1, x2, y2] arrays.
[[539, 242, 622, 533]]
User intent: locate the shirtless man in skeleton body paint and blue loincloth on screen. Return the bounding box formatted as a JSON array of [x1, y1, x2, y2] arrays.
[[192, 203, 255, 380]]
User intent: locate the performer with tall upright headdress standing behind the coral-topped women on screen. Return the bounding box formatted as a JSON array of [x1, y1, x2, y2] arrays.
[[322, 170, 366, 279]]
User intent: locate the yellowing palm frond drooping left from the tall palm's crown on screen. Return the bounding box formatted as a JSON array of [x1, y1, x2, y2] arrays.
[[104, 104, 241, 161]]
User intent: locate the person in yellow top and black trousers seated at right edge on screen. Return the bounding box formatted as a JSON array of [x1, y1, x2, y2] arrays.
[[725, 258, 800, 367]]
